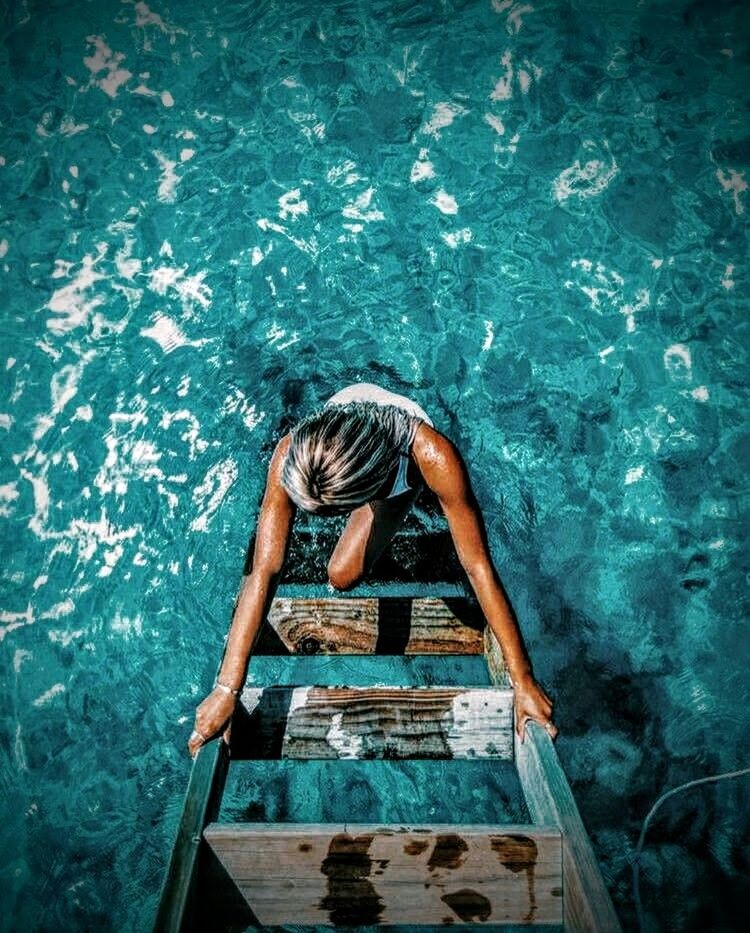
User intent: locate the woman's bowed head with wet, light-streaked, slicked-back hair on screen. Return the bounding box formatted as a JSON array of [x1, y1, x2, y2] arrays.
[[281, 402, 418, 515]]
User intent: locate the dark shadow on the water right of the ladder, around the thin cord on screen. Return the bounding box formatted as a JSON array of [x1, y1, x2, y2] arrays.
[[531, 570, 750, 933]]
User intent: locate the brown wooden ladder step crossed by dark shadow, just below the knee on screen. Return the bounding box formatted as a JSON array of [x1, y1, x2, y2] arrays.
[[255, 592, 484, 654]]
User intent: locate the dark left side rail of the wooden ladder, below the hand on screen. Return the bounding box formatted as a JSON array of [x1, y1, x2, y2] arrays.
[[154, 740, 229, 933]]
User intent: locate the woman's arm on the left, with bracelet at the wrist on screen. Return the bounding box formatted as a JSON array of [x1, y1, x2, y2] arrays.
[[188, 434, 296, 756]]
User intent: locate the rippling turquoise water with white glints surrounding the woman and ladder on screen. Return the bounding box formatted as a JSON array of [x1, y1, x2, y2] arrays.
[[0, 0, 750, 931]]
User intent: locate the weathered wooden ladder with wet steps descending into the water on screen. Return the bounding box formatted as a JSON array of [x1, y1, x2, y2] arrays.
[[155, 583, 620, 933]]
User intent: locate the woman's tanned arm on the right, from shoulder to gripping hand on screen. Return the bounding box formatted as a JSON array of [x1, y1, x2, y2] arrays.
[[413, 425, 557, 740]]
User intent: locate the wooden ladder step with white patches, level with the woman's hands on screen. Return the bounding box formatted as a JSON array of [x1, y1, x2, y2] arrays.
[[232, 687, 513, 759]]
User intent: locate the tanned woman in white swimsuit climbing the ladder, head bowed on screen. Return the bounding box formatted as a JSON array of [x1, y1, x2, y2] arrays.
[[188, 383, 557, 755]]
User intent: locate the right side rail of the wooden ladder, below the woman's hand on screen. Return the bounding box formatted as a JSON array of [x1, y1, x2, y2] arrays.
[[515, 722, 621, 933]]
